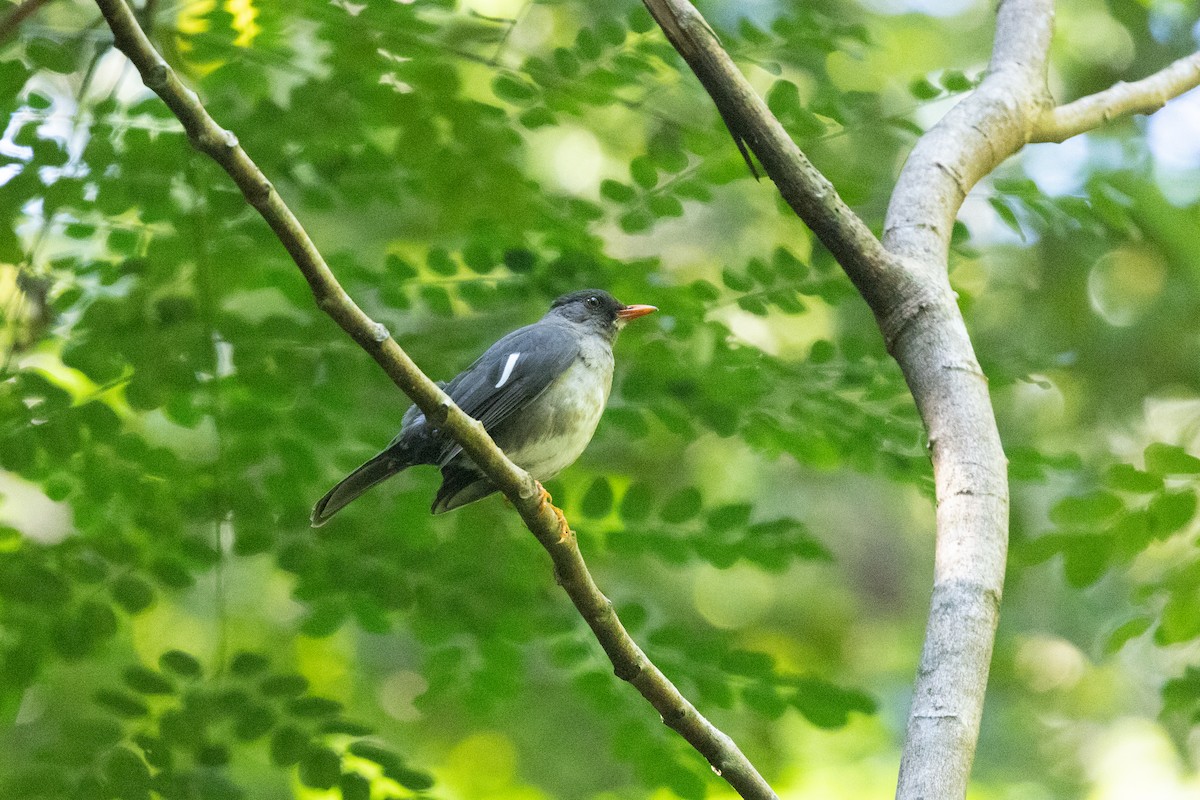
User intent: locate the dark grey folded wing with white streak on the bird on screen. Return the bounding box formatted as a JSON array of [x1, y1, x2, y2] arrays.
[[397, 321, 580, 465]]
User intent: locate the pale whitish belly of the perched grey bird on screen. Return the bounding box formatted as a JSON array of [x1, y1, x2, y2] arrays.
[[498, 356, 612, 481]]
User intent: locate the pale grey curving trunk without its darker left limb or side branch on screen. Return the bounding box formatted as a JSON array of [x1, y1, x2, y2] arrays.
[[883, 0, 1054, 800]]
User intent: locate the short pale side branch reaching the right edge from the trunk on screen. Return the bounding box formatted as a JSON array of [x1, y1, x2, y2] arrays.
[[1030, 53, 1200, 142]]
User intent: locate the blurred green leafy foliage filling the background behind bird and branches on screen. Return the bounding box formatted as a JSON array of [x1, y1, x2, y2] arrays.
[[0, 0, 1200, 800]]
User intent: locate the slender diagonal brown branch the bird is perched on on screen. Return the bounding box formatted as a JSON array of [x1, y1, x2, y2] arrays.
[[88, 0, 775, 800]]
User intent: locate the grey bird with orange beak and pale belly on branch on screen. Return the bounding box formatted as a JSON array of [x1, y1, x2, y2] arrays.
[[312, 289, 658, 528]]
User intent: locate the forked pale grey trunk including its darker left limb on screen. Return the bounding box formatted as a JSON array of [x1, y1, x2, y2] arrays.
[[643, 0, 1052, 800]]
